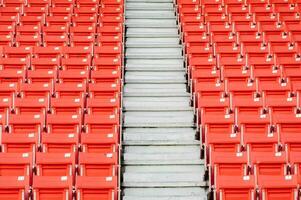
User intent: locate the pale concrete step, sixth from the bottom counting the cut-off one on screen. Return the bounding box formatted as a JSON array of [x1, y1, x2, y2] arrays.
[[123, 97, 192, 111]]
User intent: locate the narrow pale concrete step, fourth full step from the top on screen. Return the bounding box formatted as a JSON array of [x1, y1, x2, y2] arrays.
[[126, 27, 179, 38]]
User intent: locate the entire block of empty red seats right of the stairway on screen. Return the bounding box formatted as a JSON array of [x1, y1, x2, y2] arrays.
[[177, 0, 301, 200]]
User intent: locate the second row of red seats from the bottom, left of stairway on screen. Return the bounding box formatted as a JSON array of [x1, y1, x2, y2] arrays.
[[0, 152, 118, 177]]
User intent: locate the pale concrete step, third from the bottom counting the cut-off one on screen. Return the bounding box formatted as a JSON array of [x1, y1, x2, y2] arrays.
[[123, 144, 203, 165]]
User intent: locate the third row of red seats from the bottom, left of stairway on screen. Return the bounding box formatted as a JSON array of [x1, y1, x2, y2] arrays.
[[0, 130, 119, 154]]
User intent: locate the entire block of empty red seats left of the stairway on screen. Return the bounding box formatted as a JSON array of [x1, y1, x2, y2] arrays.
[[0, 0, 124, 200]]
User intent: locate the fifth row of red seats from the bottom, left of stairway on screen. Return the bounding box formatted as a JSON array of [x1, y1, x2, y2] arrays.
[[0, 96, 120, 112]]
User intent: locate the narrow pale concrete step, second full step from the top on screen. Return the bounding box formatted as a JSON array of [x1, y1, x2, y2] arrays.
[[125, 9, 176, 20]]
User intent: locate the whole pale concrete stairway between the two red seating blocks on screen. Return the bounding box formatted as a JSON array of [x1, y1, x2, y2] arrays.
[[122, 0, 206, 200]]
